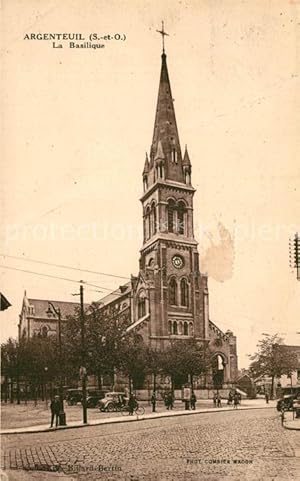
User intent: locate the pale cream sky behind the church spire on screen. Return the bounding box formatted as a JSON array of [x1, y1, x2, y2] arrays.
[[0, 0, 300, 368]]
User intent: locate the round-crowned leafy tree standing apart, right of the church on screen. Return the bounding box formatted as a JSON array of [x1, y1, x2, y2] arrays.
[[249, 334, 297, 398]]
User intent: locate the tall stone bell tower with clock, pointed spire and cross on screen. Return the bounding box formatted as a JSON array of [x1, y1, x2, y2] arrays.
[[140, 28, 208, 348]]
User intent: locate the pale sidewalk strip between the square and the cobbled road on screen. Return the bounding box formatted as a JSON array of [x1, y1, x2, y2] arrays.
[[0, 400, 278, 435]]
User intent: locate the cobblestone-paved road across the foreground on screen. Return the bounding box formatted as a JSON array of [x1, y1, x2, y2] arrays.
[[2, 409, 300, 481]]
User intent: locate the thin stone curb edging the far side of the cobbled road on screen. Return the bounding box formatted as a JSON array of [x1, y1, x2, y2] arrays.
[[0, 406, 276, 436]]
